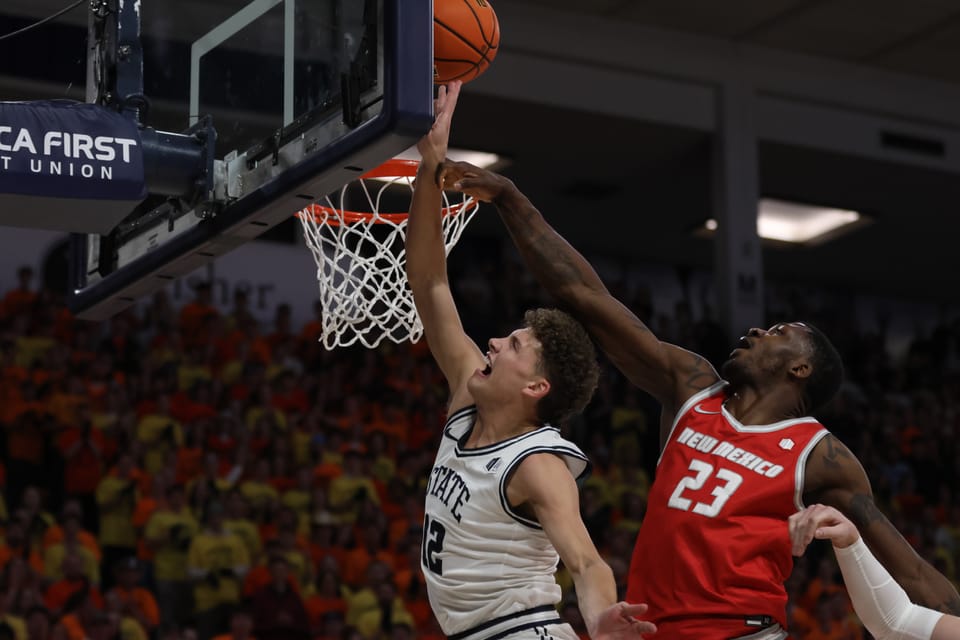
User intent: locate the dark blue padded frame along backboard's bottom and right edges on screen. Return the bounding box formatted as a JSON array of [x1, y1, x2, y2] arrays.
[[68, 0, 434, 320]]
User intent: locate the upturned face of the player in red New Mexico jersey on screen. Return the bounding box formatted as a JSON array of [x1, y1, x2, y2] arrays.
[[721, 322, 810, 383]]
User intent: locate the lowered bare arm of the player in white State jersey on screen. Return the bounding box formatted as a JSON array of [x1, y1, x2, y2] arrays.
[[507, 453, 656, 640]]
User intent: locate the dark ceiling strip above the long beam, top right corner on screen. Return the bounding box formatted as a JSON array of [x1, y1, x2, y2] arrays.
[[516, 0, 960, 82]]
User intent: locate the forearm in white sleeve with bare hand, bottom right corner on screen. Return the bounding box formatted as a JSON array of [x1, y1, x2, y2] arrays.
[[790, 504, 960, 640]]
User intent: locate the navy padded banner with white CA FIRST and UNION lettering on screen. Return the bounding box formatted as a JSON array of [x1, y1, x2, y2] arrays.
[[0, 100, 147, 202]]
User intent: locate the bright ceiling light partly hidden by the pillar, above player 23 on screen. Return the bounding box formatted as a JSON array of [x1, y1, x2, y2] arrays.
[[699, 198, 869, 245]]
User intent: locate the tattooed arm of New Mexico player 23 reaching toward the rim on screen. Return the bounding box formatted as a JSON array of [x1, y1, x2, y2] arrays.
[[443, 162, 718, 424]]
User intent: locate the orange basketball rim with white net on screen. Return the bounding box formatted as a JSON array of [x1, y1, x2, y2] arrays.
[[296, 160, 479, 349]]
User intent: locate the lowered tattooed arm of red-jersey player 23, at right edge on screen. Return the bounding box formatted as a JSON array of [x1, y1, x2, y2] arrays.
[[803, 435, 960, 615]]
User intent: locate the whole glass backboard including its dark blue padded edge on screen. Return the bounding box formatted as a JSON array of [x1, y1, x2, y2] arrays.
[[64, 0, 433, 319]]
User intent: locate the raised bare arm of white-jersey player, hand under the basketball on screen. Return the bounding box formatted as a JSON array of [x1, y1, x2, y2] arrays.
[[405, 82, 483, 409]]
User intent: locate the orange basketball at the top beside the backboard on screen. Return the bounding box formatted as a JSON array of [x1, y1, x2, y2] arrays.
[[433, 0, 500, 84]]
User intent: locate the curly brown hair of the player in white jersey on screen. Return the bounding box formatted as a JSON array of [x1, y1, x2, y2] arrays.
[[523, 309, 600, 426]]
